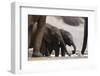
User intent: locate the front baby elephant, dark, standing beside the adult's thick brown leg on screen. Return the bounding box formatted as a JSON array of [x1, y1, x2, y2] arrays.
[[41, 24, 70, 57]]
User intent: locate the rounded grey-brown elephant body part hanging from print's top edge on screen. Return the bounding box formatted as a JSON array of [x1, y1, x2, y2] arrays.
[[62, 16, 83, 26]]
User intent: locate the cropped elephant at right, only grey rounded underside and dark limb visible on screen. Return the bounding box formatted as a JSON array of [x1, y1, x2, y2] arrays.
[[62, 16, 88, 55]]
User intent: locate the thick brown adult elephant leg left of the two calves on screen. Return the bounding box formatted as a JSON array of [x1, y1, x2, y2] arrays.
[[32, 16, 46, 57]]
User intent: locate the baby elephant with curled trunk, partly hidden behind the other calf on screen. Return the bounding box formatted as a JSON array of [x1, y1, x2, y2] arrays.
[[59, 29, 76, 54]]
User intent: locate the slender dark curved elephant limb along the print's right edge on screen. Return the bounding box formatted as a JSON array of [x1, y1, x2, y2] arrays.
[[81, 18, 88, 54]]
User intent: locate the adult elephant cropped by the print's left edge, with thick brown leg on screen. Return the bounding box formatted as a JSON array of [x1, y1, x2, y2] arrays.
[[28, 15, 46, 57]]
